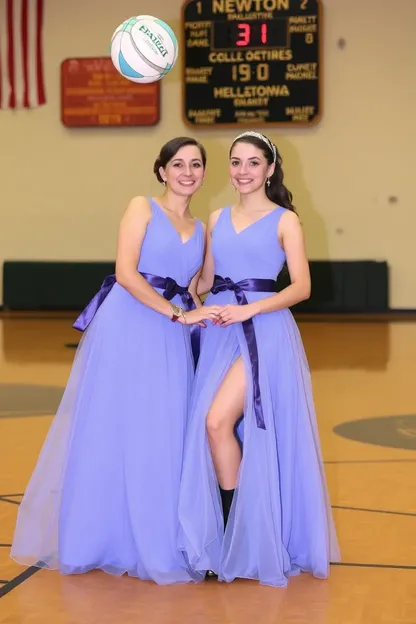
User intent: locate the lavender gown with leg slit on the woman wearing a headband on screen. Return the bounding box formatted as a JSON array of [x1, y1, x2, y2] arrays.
[[178, 207, 340, 586]]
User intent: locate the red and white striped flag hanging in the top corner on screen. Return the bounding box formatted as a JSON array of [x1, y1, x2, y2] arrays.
[[0, 0, 46, 109]]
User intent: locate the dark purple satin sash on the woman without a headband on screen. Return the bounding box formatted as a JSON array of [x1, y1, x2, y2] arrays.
[[72, 273, 201, 366]]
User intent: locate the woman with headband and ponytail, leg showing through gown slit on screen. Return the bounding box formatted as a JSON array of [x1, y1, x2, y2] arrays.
[[179, 132, 339, 586]]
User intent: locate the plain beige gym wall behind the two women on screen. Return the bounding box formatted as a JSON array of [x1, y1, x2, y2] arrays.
[[0, 0, 416, 308]]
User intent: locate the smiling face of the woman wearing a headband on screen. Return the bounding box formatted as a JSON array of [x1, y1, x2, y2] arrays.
[[230, 141, 274, 194]]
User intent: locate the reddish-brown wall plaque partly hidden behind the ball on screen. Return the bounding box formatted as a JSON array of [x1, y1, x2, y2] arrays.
[[61, 57, 160, 128]]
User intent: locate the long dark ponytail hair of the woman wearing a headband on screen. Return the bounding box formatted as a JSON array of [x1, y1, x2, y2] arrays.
[[230, 133, 296, 212]]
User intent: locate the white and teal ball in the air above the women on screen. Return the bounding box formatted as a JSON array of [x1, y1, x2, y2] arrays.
[[110, 15, 178, 83]]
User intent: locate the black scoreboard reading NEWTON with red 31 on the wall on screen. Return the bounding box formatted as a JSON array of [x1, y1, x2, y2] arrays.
[[182, 0, 322, 127]]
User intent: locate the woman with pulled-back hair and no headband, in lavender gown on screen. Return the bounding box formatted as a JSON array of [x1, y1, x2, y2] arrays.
[[11, 137, 221, 584]]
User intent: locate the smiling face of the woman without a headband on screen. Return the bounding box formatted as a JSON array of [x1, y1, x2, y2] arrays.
[[159, 145, 205, 196]]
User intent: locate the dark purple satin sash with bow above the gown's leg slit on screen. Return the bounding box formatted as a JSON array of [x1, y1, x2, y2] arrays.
[[211, 275, 276, 429]]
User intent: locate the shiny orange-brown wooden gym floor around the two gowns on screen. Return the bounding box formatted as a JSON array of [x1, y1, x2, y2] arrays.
[[0, 313, 416, 624]]
